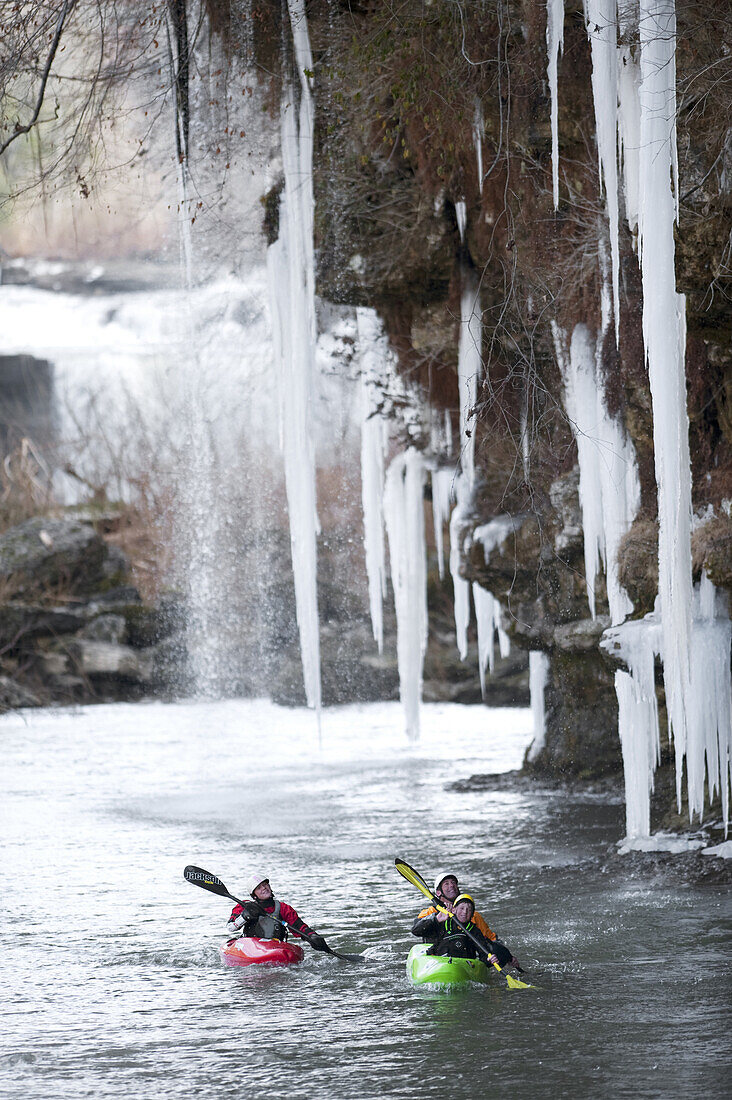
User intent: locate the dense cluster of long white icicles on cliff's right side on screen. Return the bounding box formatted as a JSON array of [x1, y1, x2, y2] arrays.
[[547, 0, 732, 838]]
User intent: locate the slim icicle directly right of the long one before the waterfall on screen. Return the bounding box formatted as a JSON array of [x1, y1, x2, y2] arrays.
[[357, 307, 387, 653]]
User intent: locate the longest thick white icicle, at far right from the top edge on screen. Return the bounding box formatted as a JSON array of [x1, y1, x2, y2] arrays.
[[638, 0, 691, 806]]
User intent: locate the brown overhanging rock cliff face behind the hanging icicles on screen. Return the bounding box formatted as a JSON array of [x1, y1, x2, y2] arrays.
[[236, 0, 732, 774]]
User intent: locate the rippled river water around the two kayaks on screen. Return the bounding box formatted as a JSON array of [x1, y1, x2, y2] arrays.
[[0, 702, 730, 1100]]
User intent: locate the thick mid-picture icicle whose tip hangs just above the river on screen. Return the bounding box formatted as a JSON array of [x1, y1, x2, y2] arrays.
[[384, 448, 427, 739]]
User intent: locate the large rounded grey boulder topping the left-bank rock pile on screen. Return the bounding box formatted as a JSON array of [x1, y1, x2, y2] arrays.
[[0, 516, 107, 594]]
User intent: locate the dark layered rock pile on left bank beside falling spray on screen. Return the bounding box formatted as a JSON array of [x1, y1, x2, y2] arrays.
[[0, 510, 181, 711]]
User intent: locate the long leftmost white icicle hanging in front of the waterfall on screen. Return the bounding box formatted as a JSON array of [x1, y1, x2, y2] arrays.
[[267, 0, 320, 715]]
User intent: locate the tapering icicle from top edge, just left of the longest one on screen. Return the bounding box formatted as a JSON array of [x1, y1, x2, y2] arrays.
[[584, 0, 620, 343]]
